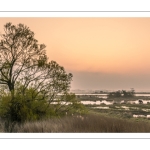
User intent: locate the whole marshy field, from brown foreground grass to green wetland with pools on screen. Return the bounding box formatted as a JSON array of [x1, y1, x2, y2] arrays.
[[0, 96, 150, 133]]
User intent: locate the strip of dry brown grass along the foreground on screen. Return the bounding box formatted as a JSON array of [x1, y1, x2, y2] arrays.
[[0, 114, 150, 133]]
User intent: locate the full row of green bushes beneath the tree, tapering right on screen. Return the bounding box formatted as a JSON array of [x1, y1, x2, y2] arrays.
[[0, 86, 87, 123]]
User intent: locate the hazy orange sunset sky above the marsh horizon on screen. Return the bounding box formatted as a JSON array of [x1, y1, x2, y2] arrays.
[[0, 17, 150, 91]]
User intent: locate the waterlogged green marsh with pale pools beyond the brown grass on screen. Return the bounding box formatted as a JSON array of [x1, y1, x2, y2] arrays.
[[78, 95, 150, 120]]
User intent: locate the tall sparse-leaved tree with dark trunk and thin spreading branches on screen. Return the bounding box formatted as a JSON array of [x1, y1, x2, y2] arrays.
[[0, 23, 85, 121]]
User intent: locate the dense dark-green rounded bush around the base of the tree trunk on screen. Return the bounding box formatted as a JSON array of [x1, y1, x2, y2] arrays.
[[0, 90, 48, 122]]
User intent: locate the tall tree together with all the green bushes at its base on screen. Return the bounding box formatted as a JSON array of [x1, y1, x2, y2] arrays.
[[0, 23, 84, 123]]
